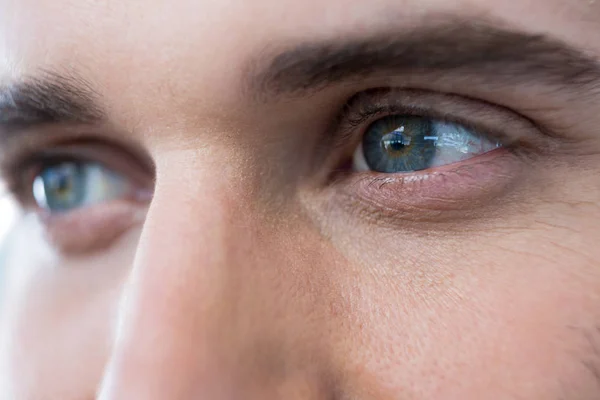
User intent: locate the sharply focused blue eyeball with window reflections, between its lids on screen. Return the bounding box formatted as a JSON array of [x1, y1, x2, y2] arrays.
[[354, 115, 501, 173]]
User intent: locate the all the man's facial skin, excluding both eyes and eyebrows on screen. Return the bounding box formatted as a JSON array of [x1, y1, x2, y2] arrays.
[[0, 0, 600, 400]]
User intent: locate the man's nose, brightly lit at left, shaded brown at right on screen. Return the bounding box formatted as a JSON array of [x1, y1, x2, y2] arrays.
[[98, 148, 346, 400]]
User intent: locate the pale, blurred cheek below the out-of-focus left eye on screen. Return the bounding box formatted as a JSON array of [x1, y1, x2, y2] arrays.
[[0, 223, 139, 399]]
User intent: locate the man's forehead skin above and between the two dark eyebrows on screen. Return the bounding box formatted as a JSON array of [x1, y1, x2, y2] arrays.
[[0, 0, 600, 122]]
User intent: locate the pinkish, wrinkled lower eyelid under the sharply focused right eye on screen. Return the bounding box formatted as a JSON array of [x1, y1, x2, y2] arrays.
[[333, 148, 523, 221]]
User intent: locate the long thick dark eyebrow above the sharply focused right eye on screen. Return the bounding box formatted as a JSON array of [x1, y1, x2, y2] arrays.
[[244, 18, 600, 100]]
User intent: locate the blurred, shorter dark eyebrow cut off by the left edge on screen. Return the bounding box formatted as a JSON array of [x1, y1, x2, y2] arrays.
[[0, 72, 105, 132]]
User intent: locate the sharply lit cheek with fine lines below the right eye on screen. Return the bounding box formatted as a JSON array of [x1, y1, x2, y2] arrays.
[[328, 231, 600, 399]]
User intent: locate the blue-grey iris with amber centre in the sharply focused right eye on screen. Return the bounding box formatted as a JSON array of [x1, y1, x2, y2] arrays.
[[363, 115, 437, 173]]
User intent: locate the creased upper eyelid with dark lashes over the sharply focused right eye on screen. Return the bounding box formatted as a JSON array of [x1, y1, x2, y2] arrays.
[[298, 87, 544, 184]]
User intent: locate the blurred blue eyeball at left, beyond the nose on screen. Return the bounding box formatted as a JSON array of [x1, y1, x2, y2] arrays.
[[33, 161, 129, 212]]
